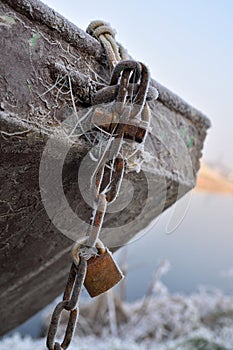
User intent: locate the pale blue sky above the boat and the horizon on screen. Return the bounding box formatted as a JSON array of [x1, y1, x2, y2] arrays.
[[44, 0, 233, 170]]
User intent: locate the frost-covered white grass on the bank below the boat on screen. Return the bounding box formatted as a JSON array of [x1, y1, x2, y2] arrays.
[[0, 264, 233, 350]]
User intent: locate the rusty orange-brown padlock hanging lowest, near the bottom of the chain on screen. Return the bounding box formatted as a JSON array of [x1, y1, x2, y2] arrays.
[[72, 238, 124, 297]]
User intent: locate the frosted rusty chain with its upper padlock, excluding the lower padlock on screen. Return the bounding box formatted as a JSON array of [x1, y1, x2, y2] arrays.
[[47, 22, 157, 350]]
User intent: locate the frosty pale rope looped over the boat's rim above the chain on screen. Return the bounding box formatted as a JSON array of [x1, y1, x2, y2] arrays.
[[86, 20, 129, 69]]
